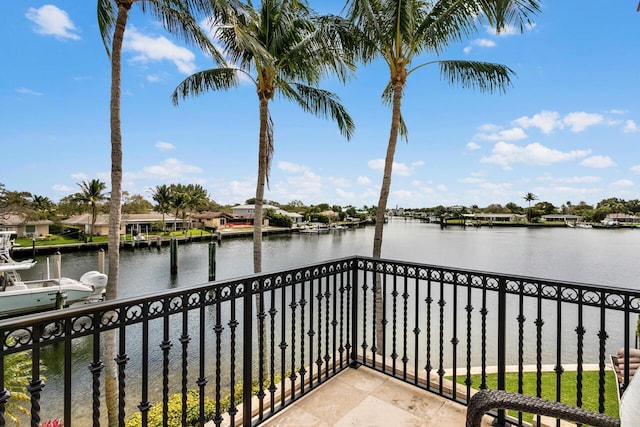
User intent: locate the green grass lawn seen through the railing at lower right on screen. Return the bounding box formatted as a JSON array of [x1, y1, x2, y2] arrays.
[[457, 371, 618, 423]]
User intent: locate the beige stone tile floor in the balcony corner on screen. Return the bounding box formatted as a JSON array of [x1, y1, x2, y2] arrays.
[[261, 367, 484, 427]]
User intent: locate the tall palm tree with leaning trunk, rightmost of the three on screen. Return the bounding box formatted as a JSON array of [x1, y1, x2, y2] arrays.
[[346, 0, 540, 258]]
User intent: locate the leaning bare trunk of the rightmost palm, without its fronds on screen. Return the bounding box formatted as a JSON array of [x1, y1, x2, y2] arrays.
[[373, 80, 404, 363]]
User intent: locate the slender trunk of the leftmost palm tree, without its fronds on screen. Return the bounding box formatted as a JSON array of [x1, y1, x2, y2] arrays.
[[103, 3, 131, 427]]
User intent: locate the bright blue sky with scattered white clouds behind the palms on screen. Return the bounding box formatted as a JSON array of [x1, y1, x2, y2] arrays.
[[0, 0, 640, 211]]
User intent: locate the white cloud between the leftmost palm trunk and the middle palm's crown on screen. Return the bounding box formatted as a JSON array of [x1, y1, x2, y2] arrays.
[[122, 27, 196, 74]]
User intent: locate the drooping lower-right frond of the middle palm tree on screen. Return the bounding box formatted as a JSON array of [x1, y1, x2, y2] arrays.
[[280, 83, 355, 139]]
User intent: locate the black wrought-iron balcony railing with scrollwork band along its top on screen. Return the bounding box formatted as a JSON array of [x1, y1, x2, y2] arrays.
[[0, 257, 640, 427]]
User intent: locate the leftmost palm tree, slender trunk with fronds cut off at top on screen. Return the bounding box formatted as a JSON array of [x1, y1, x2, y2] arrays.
[[97, 0, 225, 427]]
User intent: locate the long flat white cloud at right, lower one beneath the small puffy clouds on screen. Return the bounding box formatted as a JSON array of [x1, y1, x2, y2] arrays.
[[480, 141, 590, 168]]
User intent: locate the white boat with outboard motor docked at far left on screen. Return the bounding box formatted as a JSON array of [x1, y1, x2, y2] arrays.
[[0, 231, 107, 317]]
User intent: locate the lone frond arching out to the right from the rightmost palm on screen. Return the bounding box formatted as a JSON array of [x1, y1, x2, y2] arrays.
[[439, 61, 515, 93]]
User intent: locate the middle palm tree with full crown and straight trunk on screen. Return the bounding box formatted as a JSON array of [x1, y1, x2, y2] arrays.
[[173, 0, 354, 273]]
